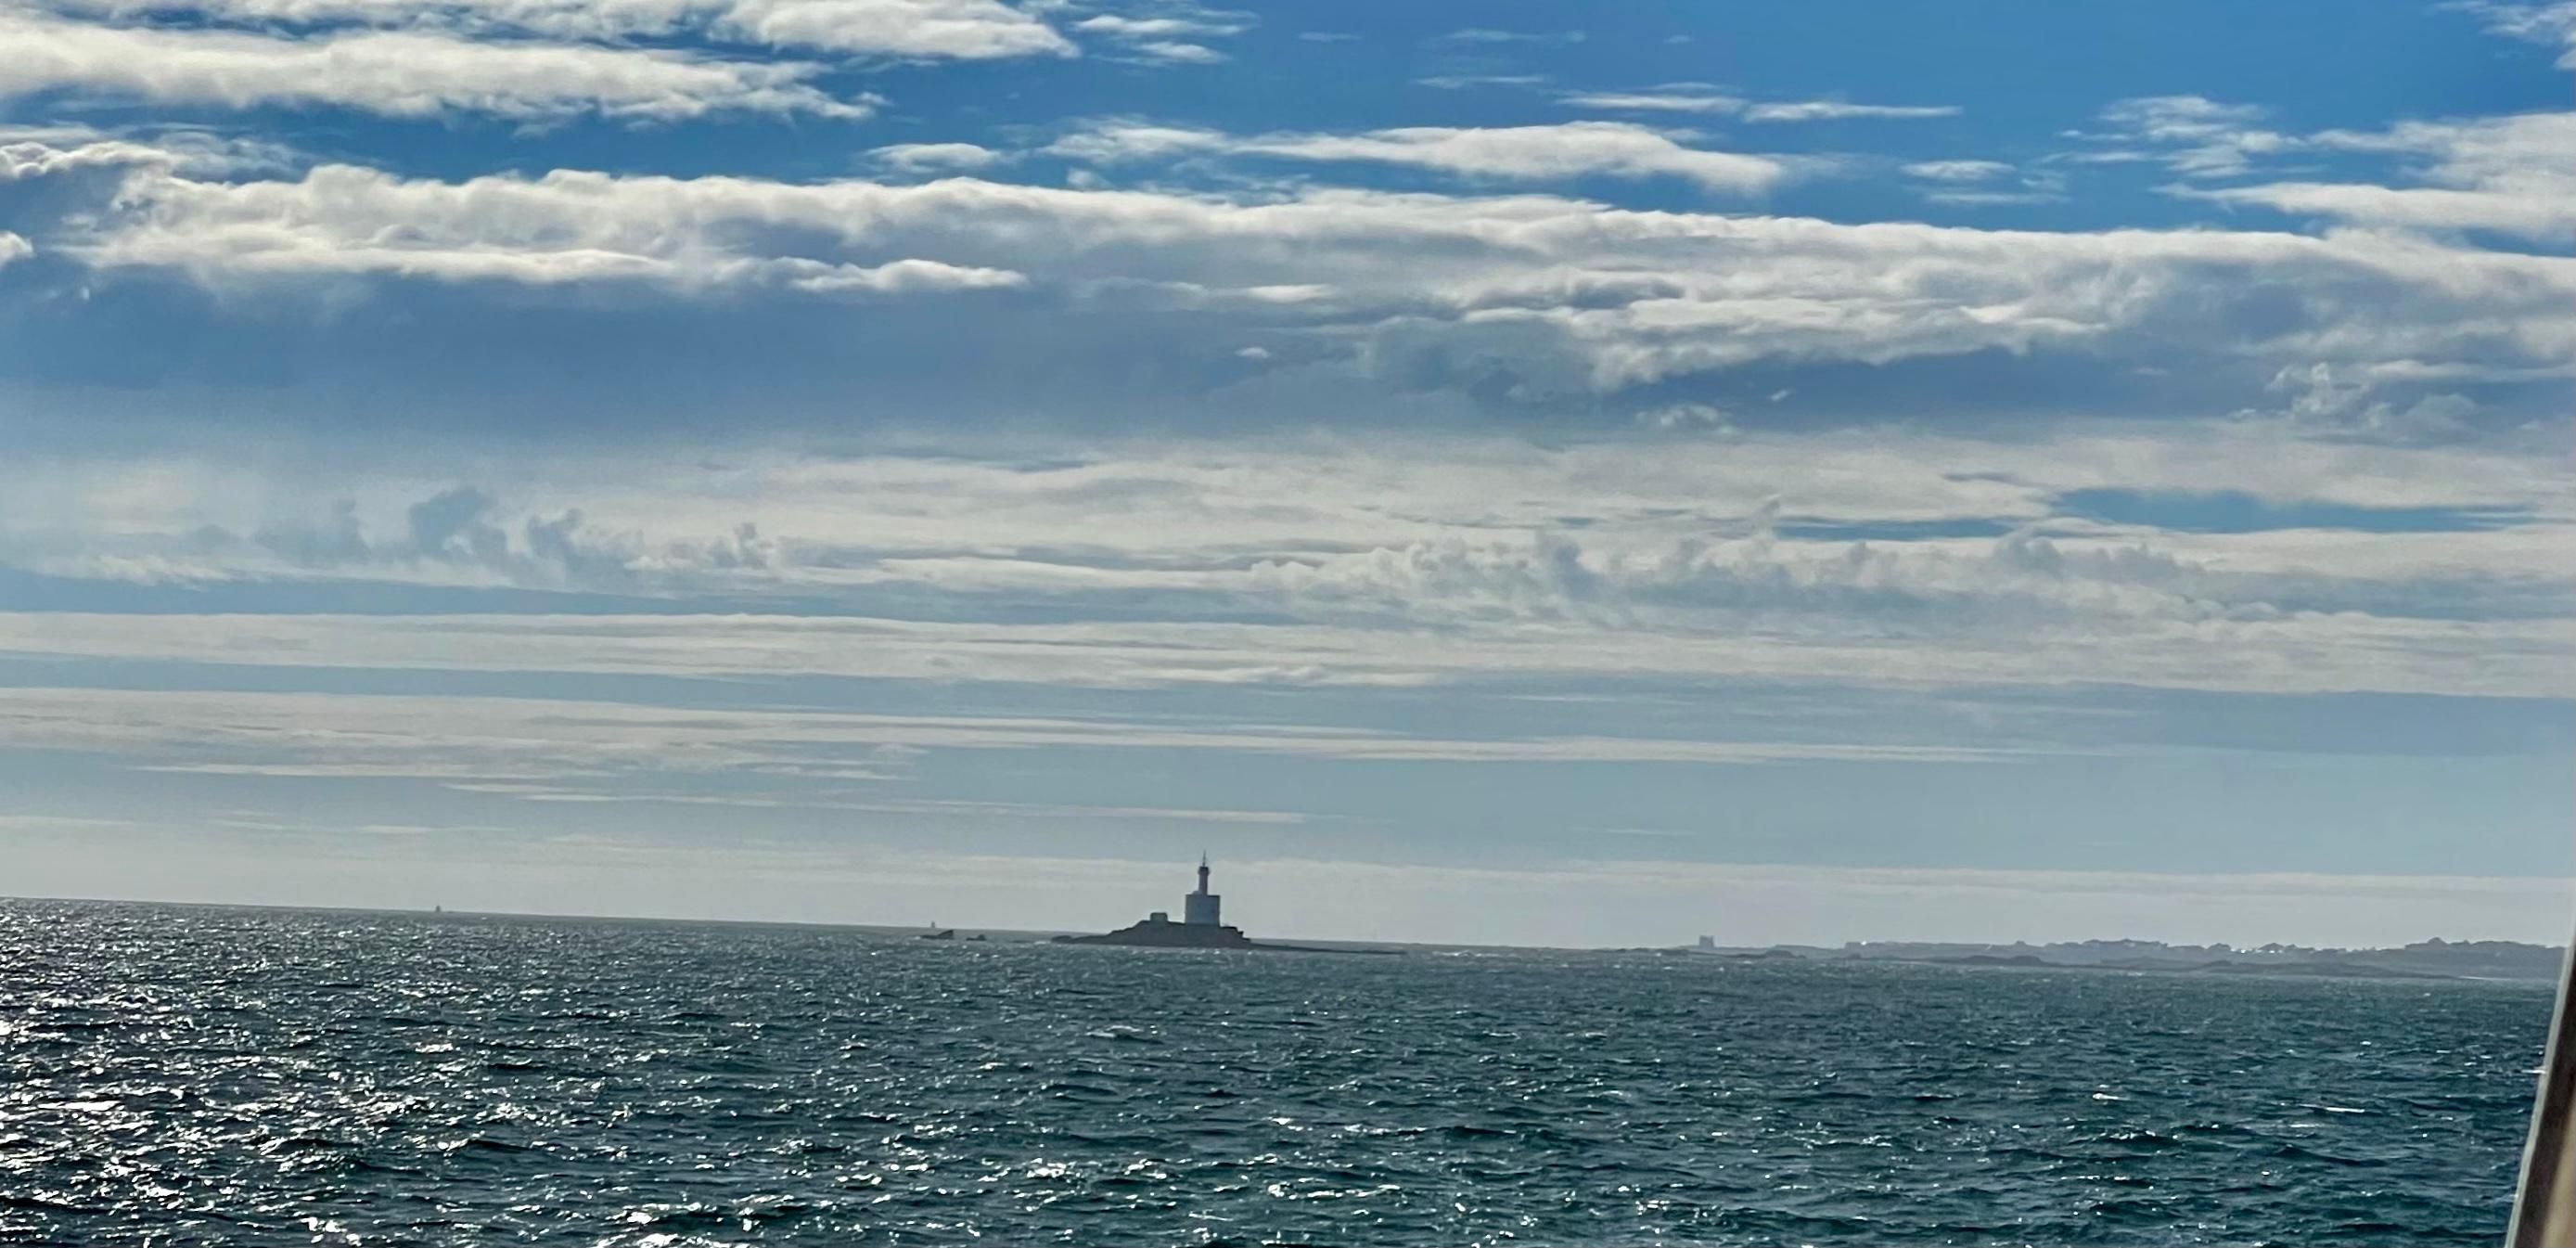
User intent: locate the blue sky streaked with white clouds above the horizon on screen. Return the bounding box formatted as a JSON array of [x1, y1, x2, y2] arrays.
[[0, 0, 2576, 944]]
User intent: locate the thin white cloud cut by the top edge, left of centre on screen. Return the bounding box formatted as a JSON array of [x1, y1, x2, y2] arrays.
[[32, 0, 1080, 59]]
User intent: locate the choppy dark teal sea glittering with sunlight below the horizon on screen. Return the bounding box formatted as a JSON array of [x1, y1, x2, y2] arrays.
[[0, 903, 2547, 1245]]
